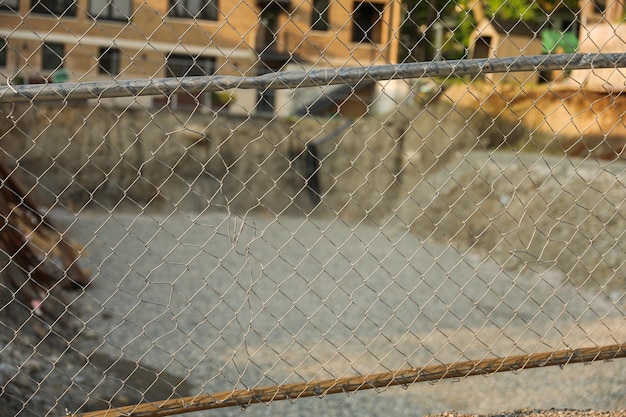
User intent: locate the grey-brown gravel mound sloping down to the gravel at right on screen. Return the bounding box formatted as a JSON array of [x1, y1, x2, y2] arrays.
[[398, 151, 626, 292]]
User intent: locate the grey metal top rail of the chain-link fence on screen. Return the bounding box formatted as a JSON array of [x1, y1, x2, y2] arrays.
[[0, 53, 626, 103]]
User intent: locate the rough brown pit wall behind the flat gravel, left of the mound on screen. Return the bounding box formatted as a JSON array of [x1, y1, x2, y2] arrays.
[[0, 98, 478, 218]]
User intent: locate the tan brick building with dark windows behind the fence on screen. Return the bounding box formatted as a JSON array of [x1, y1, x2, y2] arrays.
[[0, 0, 401, 113]]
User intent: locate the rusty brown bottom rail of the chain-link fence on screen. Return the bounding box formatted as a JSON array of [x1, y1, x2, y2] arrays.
[[72, 343, 626, 417]]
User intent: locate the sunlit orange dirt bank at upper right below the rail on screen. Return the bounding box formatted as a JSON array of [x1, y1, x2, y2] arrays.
[[442, 83, 626, 160]]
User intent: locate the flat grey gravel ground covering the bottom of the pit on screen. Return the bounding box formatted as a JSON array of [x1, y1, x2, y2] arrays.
[[0, 203, 626, 416]]
